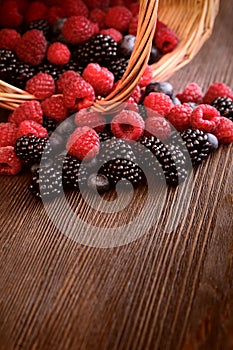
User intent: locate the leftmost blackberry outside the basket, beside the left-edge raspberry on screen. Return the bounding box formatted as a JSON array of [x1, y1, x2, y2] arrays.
[[15, 135, 51, 165]]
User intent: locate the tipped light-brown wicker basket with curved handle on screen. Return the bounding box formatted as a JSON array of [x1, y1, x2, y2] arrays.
[[0, 0, 220, 112]]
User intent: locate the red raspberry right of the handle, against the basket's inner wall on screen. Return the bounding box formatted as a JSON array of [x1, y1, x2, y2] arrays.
[[154, 27, 178, 54]]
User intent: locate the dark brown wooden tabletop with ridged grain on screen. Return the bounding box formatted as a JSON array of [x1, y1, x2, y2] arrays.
[[0, 0, 233, 350]]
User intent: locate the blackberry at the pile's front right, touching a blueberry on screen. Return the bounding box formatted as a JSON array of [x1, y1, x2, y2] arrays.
[[180, 128, 212, 166]]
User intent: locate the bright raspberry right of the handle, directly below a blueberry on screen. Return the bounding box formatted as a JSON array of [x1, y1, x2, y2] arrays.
[[144, 92, 173, 117]]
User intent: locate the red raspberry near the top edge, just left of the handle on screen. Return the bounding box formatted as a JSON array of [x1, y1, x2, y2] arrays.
[[105, 6, 132, 33]]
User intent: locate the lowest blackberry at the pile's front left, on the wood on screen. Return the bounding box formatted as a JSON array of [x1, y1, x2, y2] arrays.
[[29, 162, 62, 200]]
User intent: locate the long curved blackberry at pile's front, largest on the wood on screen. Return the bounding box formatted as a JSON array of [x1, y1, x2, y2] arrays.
[[140, 136, 187, 186]]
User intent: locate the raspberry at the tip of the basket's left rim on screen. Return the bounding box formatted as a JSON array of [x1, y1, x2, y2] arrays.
[[25, 73, 55, 100]]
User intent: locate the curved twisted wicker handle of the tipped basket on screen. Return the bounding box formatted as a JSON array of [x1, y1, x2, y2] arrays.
[[93, 0, 159, 113]]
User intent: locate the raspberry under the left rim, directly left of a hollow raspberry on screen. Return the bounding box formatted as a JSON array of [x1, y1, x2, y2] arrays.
[[41, 95, 68, 122]]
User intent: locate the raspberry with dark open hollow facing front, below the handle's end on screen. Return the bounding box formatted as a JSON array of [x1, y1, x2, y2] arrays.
[[111, 110, 145, 140]]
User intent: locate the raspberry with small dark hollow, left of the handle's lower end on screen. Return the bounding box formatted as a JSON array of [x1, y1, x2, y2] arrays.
[[63, 77, 95, 109]]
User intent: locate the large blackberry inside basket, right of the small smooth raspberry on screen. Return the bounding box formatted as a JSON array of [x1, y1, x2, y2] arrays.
[[74, 34, 117, 66]]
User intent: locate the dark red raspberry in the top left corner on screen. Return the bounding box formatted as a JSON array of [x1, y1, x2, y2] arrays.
[[0, 0, 23, 28]]
